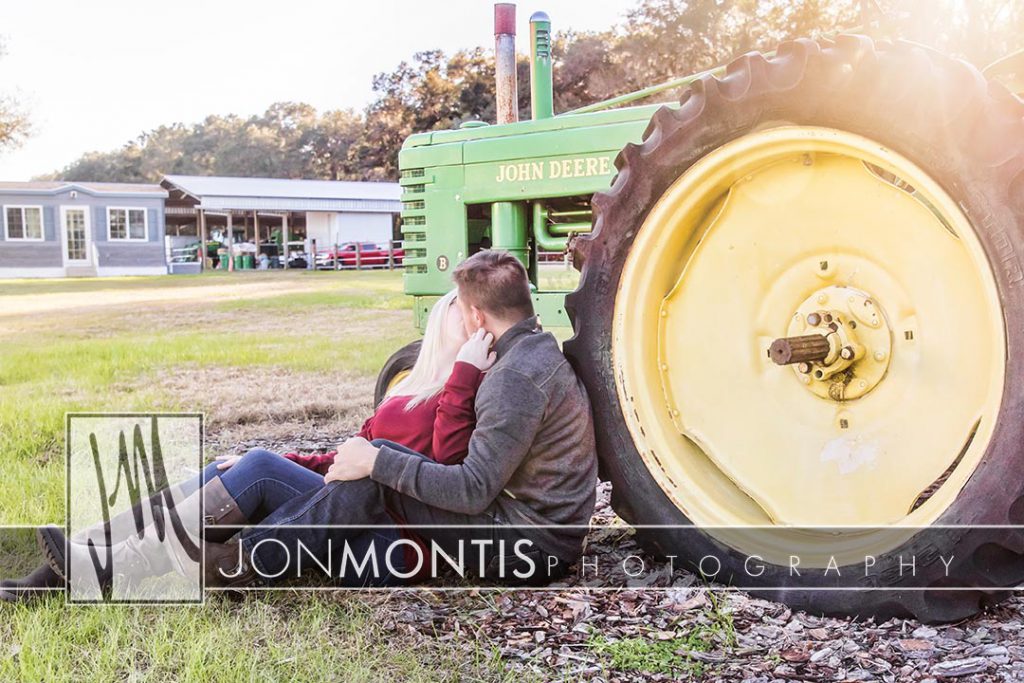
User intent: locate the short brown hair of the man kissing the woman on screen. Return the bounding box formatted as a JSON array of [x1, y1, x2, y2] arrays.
[[452, 249, 534, 321]]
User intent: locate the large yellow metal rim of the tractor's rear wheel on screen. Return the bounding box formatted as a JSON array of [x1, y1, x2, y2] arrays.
[[611, 126, 1007, 565]]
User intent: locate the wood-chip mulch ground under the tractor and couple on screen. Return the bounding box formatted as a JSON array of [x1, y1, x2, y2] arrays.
[[224, 433, 1024, 683]]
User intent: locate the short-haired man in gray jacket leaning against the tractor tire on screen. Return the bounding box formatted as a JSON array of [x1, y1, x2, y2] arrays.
[[216, 251, 597, 586]]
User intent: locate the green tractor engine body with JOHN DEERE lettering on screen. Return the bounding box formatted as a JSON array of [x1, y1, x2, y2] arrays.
[[398, 105, 658, 327]]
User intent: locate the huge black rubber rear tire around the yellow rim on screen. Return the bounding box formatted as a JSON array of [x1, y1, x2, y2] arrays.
[[565, 36, 1024, 622]]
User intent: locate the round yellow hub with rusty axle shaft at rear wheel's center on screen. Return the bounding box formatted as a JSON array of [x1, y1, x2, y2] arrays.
[[768, 284, 892, 400]]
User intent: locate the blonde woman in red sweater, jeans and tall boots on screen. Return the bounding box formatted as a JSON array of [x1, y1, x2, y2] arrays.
[[7, 290, 495, 602]]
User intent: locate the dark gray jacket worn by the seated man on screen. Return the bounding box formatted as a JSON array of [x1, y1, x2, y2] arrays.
[[371, 316, 597, 562]]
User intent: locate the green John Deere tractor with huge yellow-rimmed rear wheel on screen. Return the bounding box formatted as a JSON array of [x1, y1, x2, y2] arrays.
[[378, 5, 1024, 621]]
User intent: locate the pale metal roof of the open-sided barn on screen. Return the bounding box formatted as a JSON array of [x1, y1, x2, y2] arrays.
[[163, 175, 401, 213]]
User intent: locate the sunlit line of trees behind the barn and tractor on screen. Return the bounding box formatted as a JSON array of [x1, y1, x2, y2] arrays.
[[0, 0, 1024, 182]]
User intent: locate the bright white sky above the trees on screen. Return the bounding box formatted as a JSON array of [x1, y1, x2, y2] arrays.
[[0, 0, 635, 180]]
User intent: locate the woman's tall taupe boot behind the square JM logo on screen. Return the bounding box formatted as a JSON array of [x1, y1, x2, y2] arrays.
[[38, 478, 247, 591]]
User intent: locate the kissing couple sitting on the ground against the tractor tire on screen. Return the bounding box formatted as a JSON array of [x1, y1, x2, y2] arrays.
[[0, 251, 597, 601]]
